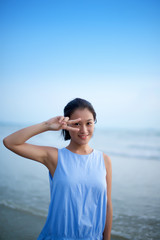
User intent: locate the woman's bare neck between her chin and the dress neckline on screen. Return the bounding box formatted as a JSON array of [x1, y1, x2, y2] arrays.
[[67, 141, 93, 154]]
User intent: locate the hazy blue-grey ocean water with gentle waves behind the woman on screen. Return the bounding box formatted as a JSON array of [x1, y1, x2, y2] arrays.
[[0, 124, 160, 240]]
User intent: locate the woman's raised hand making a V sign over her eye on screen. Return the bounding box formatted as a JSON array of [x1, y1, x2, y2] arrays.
[[45, 116, 81, 131]]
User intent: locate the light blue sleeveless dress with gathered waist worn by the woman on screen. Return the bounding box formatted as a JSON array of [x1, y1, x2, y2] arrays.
[[38, 148, 107, 240]]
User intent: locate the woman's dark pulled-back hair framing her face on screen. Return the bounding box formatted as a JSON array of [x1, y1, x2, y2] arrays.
[[62, 98, 97, 141]]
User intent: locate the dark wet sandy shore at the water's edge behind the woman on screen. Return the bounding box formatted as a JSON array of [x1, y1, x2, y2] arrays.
[[0, 205, 125, 240]]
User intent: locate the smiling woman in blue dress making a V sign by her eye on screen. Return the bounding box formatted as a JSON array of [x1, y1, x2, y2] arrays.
[[4, 98, 112, 240]]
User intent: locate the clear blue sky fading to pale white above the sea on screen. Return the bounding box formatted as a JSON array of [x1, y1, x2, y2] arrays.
[[0, 0, 160, 129]]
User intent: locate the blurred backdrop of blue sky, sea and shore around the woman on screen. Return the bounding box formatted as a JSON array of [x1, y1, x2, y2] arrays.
[[0, 0, 160, 240]]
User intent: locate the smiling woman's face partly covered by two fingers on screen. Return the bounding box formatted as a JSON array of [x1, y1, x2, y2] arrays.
[[69, 108, 94, 145]]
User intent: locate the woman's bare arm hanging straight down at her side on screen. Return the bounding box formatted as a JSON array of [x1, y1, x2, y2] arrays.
[[103, 154, 113, 240]]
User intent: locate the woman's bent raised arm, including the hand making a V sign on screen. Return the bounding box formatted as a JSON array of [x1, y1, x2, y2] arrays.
[[3, 116, 79, 173]]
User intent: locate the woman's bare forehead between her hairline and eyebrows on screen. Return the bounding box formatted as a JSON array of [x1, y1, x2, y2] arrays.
[[70, 108, 94, 121]]
